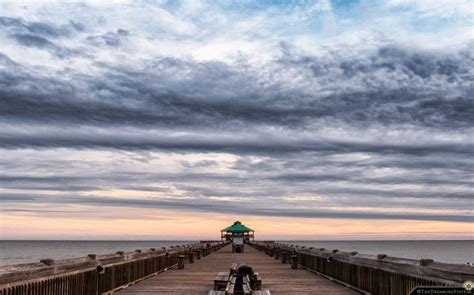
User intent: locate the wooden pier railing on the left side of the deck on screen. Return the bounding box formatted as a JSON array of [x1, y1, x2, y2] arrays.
[[0, 242, 230, 295]]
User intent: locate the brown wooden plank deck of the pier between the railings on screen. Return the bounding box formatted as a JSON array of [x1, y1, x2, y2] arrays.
[[118, 245, 358, 295]]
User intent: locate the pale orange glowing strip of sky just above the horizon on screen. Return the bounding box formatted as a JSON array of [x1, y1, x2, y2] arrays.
[[0, 207, 474, 240]]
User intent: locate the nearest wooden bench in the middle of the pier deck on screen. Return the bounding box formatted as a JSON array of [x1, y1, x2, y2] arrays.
[[209, 263, 270, 295]]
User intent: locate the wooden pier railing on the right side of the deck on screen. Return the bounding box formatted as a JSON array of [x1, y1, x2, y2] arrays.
[[249, 241, 474, 295]]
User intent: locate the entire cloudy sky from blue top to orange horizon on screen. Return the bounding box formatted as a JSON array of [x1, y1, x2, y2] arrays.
[[0, 0, 474, 240]]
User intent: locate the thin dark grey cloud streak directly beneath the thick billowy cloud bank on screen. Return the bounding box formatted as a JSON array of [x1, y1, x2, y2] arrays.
[[0, 130, 474, 156]]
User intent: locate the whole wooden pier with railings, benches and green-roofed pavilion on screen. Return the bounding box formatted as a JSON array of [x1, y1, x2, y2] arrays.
[[0, 221, 474, 295]]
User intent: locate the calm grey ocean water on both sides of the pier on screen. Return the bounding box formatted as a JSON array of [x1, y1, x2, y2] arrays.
[[0, 240, 474, 265]]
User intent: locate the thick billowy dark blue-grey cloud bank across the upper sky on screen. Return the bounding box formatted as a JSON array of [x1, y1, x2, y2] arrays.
[[1, 42, 474, 129]]
